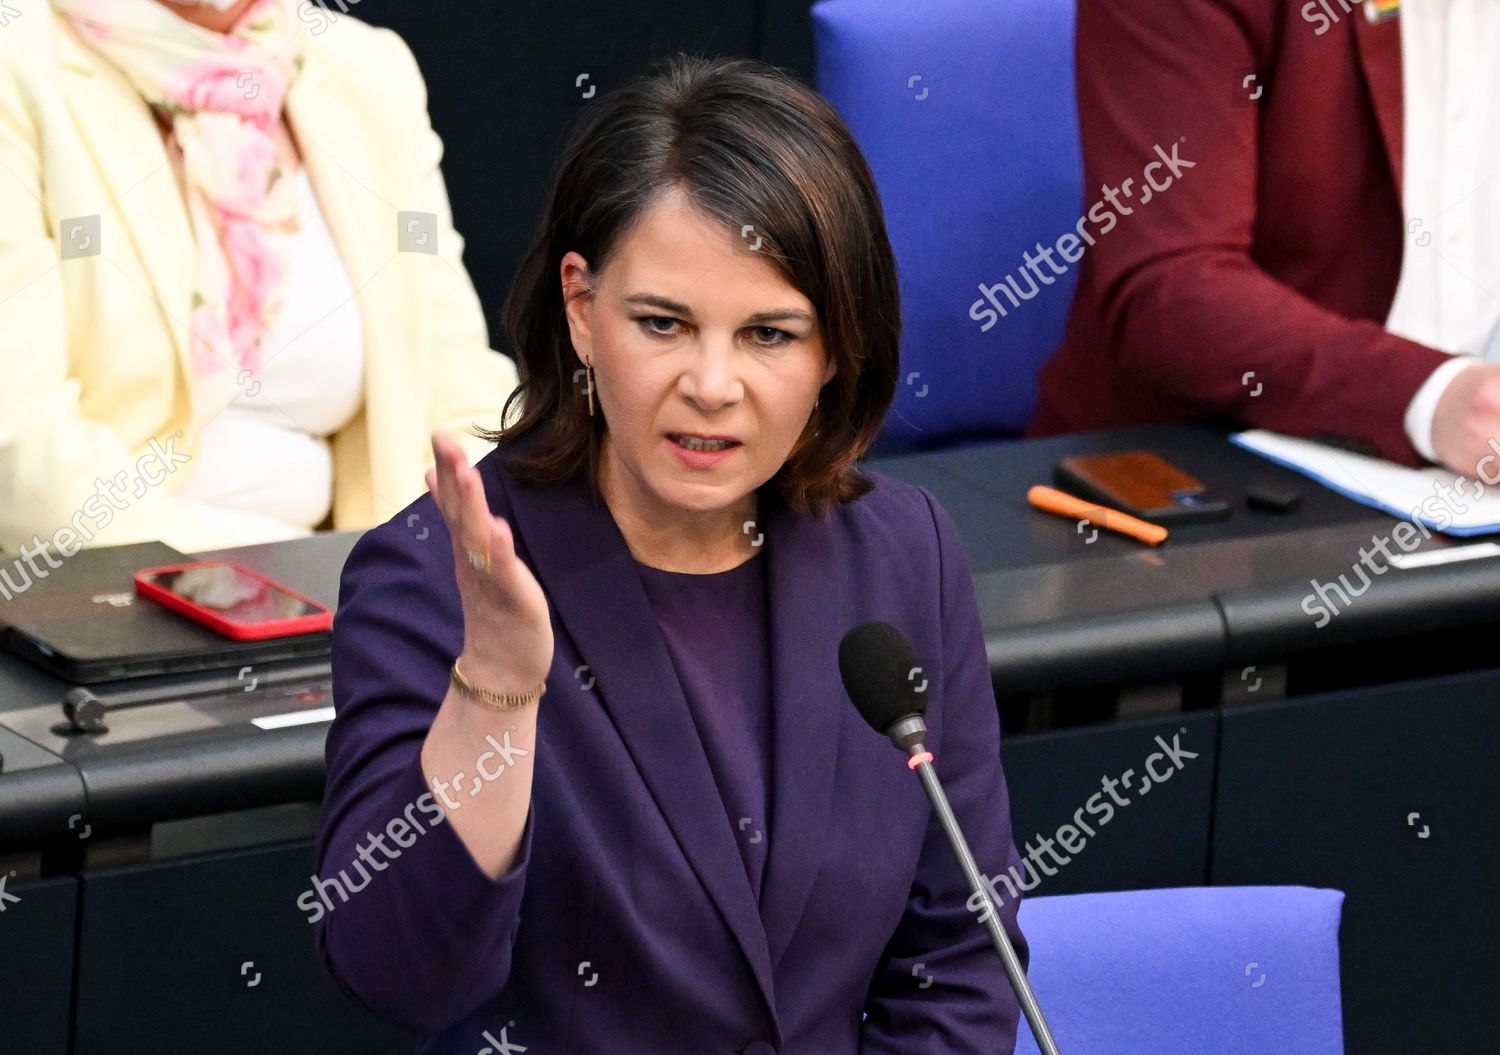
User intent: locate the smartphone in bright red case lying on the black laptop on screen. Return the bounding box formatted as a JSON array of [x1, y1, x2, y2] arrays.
[[135, 561, 333, 641]]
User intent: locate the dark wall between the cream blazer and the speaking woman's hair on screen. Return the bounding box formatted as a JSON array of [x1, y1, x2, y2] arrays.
[[351, 0, 813, 345]]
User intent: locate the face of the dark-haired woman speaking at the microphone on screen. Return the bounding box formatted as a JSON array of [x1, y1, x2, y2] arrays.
[[563, 191, 836, 525]]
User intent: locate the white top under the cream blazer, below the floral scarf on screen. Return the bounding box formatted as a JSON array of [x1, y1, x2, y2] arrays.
[[179, 168, 365, 545]]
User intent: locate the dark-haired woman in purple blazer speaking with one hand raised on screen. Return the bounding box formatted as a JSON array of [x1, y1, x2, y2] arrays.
[[316, 57, 1025, 1055]]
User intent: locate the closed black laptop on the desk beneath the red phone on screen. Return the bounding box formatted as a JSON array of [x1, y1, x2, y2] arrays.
[[0, 542, 330, 684]]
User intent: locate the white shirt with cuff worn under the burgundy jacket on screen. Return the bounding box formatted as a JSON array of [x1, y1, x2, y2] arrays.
[[1386, 0, 1500, 461]]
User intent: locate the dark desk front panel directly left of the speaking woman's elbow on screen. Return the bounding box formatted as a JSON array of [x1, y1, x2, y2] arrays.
[[72, 842, 417, 1055]]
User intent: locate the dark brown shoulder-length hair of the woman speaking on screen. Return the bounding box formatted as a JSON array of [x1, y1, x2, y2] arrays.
[[485, 54, 902, 516]]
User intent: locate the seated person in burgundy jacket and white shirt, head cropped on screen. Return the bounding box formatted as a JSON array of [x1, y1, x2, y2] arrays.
[[1028, 0, 1500, 474]]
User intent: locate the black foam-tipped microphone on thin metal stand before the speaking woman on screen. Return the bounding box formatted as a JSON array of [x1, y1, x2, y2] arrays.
[[839, 620, 1059, 1055]]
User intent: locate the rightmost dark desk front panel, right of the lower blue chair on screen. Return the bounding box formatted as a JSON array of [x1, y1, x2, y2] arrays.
[[1212, 671, 1500, 1055]]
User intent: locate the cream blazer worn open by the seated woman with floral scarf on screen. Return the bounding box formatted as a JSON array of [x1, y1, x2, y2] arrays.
[[0, 6, 516, 552]]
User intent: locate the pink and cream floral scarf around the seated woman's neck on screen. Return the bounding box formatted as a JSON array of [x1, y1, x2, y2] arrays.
[[53, 0, 306, 375]]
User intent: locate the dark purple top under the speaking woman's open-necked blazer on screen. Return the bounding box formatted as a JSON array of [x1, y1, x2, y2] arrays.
[[636, 554, 774, 903]]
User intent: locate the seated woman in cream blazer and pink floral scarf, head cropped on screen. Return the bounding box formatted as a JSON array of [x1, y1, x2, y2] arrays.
[[0, 0, 516, 555]]
